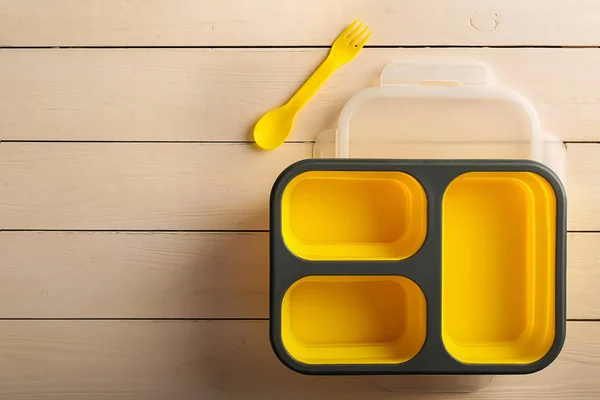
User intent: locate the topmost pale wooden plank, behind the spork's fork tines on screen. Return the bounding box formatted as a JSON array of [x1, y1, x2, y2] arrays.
[[0, 0, 600, 46]]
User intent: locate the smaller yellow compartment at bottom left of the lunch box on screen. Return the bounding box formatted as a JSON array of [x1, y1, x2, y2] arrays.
[[281, 276, 426, 364]]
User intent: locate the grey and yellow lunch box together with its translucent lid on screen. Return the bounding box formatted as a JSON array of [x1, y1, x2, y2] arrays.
[[270, 63, 566, 374]]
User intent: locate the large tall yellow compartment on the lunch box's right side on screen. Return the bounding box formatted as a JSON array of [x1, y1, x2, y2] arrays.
[[442, 172, 556, 364]]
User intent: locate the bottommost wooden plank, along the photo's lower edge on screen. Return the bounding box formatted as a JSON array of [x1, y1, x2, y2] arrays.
[[0, 321, 600, 400]]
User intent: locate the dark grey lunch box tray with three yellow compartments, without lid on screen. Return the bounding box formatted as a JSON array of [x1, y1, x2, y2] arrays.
[[270, 159, 566, 374]]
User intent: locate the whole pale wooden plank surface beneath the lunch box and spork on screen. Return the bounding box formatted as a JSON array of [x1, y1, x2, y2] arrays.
[[0, 0, 600, 400]]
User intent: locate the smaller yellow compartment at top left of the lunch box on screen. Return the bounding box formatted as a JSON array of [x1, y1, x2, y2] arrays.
[[281, 171, 427, 260]]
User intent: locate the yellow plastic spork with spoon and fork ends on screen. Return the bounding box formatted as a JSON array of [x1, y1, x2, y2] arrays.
[[254, 21, 371, 150]]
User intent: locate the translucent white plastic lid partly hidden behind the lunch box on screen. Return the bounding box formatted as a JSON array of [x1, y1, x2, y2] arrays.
[[314, 61, 566, 183]]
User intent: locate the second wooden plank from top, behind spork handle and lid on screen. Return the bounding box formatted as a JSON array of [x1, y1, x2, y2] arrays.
[[0, 48, 600, 141]]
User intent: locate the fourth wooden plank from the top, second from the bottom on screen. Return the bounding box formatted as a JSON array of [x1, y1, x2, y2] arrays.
[[0, 232, 600, 319]]
